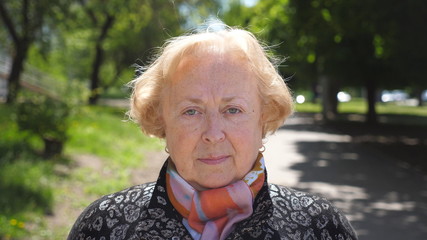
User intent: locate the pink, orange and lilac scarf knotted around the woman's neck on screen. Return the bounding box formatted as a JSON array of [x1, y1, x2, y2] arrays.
[[166, 153, 265, 240]]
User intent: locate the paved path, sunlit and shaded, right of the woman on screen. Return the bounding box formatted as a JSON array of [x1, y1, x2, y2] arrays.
[[264, 113, 427, 240]]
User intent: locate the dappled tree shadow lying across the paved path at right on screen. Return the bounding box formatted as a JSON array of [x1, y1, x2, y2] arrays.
[[292, 142, 427, 239]]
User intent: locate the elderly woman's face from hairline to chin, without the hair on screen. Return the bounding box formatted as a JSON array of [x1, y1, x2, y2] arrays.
[[161, 54, 262, 190]]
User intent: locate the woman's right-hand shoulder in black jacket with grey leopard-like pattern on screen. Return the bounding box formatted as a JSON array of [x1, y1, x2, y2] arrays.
[[269, 184, 357, 239]]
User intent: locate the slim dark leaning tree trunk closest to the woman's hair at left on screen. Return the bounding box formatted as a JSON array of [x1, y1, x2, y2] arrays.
[[89, 15, 114, 105]]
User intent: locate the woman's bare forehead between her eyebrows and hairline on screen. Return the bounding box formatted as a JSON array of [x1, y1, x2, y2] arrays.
[[165, 51, 259, 101]]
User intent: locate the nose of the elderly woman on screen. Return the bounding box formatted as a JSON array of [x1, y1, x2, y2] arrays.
[[202, 114, 225, 144]]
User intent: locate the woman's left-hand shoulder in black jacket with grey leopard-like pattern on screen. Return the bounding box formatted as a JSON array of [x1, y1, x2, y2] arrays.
[[68, 182, 155, 239]]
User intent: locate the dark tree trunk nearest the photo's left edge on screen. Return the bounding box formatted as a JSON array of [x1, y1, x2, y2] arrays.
[[6, 41, 29, 104]]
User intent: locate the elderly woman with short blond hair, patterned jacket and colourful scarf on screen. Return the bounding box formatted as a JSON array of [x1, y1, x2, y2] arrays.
[[68, 23, 357, 239]]
